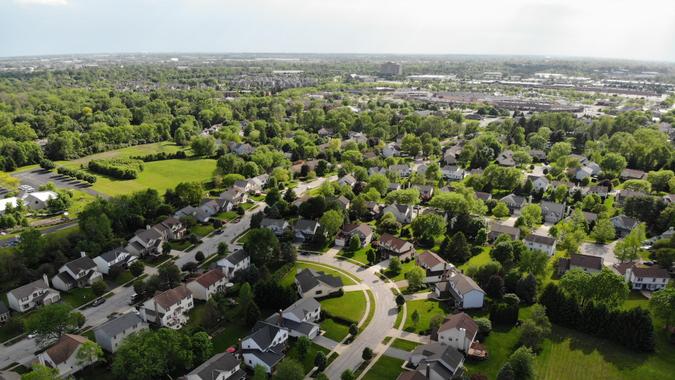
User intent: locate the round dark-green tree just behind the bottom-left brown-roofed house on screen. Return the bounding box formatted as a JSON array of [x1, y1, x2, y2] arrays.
[[24, 303, 79, 345]]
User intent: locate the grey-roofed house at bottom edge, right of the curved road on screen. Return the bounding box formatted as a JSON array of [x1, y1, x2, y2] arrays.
[[406, 342, 464, 380]]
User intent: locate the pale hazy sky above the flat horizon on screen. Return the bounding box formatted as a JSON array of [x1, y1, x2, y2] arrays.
[[0, 0, 675, 62]]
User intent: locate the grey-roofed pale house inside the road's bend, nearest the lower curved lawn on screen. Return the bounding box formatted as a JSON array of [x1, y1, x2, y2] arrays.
[[265, 297, 321, 339]]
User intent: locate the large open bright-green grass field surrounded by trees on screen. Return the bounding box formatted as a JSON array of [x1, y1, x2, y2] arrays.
[[73, 158, 216, 196]]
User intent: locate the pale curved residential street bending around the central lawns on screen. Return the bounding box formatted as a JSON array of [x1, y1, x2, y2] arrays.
[[302, 249, 398, 379]]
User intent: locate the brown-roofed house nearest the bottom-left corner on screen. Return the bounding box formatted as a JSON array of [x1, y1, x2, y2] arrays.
[[37, 334, 97, 378]]
